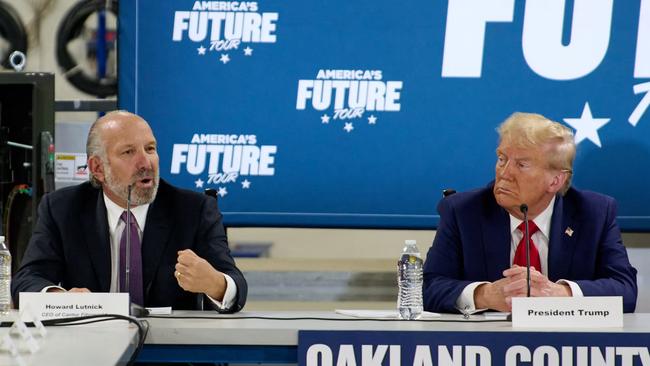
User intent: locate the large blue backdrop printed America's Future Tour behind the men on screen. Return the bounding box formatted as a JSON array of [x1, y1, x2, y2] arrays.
[[119, 0, 650, 230]]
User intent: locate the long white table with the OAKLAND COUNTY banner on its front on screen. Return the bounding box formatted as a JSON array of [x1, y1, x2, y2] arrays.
[[138, 311, 650, 363]]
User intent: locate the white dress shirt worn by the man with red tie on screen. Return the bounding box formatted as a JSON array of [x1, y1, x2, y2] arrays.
[[456, 199, 583, 311]]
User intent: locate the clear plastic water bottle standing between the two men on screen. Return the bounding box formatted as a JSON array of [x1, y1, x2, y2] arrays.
[[397, 240, 422, 320]]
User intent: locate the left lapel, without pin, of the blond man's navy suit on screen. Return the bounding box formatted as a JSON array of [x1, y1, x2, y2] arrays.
[[481, 196, 511, 281]]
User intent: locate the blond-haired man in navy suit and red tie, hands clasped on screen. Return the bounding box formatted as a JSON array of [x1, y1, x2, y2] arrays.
[[423, 113, 637, 312]]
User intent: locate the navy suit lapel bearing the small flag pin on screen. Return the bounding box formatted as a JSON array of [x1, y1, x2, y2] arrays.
[[548, 195, 580, 281]]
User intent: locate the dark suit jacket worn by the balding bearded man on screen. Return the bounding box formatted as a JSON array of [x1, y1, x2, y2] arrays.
[[11, 179, 248, 312]]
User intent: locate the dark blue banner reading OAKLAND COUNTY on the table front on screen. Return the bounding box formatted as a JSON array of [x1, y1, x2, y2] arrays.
[[298, 331, 650, 366]]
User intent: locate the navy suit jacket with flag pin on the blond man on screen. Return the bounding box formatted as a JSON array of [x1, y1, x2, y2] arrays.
[[423, 184, 637, 312]]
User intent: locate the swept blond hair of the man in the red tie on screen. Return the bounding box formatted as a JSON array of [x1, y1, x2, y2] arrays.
[[497, 112, 576, 195]]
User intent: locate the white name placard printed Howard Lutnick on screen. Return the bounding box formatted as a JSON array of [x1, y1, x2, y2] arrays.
[[20, 292, 129, 321]]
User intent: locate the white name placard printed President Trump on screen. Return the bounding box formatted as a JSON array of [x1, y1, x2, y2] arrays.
[[512, 296, 623, 328]]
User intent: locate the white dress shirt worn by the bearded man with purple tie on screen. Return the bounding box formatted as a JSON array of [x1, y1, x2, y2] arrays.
[[42, 193, 237, 310]]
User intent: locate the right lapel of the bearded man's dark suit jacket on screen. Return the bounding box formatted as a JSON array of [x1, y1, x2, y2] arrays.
[[142, 180, 174, 301]]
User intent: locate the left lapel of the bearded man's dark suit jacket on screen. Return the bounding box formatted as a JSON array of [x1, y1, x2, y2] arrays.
[[81, 189, 111, 292]]
